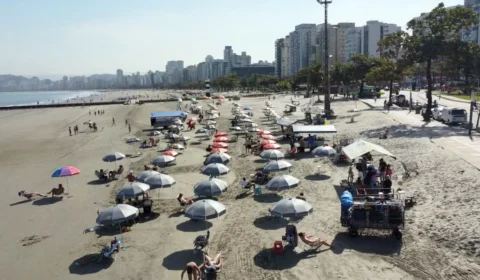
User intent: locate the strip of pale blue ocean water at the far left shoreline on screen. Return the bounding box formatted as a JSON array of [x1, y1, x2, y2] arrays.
[[0, 91, 101, 106]]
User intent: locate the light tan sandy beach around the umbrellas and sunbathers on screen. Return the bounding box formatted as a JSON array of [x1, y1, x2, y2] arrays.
[[0, 91, 480, 280]]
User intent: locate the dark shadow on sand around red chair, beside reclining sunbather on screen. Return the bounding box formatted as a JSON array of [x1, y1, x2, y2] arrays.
[[253, 246, 325, 270]]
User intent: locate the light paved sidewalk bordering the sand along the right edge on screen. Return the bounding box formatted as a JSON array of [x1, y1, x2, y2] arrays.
[[361, 99, 480, 170]]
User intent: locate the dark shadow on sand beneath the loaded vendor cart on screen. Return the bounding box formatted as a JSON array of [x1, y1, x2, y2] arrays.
[[332, 231, 403, 256]]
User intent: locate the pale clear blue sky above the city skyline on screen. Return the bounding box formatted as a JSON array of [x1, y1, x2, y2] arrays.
[[0, 0, 463, 77]]
